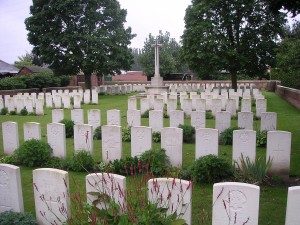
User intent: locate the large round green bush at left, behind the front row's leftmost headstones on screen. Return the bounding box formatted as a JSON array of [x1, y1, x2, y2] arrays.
[[15, 139, 53, 167]]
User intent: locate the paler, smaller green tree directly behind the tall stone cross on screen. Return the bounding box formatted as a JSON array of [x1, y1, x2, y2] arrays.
[[138, 31, 187, 77]]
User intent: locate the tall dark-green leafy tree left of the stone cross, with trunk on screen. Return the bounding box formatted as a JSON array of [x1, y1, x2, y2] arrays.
[[25, 0, 134, 88]]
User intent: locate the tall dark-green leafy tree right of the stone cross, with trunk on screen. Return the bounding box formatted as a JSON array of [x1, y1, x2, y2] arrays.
[[182, 0, 285, 89]]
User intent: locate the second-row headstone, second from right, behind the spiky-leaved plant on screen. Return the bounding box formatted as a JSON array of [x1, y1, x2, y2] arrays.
[[232, 130, 256, 165]]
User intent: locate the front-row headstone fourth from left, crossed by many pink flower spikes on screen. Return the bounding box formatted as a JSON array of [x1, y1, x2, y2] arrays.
[[148, 178, 192, 225]]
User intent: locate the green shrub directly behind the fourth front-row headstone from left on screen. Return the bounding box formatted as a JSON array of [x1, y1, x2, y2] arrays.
[[140, 149, 171, 176]]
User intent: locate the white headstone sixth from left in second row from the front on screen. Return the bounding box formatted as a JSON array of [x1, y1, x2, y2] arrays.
[[131, 126, 152, 157]]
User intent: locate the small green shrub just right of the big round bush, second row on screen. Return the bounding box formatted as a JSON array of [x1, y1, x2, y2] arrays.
[[72, 150, 95, 172]]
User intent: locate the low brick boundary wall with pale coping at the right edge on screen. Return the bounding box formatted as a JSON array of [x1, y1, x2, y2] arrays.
[[275, 85, 300, 109]]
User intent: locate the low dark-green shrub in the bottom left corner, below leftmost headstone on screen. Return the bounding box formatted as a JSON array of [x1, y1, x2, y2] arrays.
[[0, 211, 37, 225]]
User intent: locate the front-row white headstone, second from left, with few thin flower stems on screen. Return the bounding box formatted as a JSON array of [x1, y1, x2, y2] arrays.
[[32, 168, 70, 225]]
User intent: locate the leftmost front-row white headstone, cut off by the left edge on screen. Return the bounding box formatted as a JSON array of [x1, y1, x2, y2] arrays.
[[0, 164, 24, 213]]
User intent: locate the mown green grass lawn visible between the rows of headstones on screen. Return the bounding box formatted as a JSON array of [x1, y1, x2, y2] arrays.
[[0, 92, 300, 225]]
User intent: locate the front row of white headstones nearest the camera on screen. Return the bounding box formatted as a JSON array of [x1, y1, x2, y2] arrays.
[[0, 164, 300, 225]]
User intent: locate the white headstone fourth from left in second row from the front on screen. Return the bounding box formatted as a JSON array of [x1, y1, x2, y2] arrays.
[[74, 124, 93, 154]]
